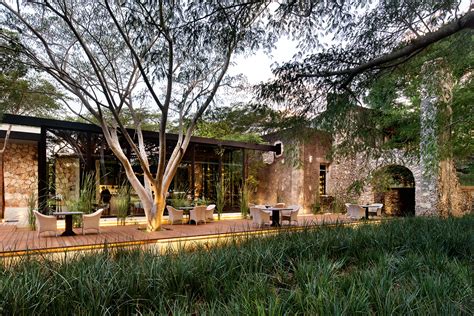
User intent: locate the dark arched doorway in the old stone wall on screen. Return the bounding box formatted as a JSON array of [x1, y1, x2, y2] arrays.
[[372, 165, 415, 216]]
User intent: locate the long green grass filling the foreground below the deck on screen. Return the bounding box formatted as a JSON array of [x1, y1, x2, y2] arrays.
[[0, 215, 474, 315]]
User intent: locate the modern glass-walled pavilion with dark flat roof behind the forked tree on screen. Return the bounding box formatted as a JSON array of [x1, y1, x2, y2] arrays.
[[0, 114, 281, 217]]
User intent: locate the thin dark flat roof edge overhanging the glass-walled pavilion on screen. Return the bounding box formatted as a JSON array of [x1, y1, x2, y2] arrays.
[[0, 114, 280, 152]]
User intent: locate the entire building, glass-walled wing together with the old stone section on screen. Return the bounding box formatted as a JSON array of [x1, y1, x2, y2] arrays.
[[0, 115, 472, 225]]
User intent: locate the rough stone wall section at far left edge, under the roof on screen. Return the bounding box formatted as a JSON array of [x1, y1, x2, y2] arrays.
[[3, 140, 38, 209]]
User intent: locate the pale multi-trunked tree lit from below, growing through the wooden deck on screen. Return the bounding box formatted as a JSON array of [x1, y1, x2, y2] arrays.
[[2, 0, 271, 231]]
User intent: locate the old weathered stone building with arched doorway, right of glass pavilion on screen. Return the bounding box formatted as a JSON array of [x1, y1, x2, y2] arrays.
[[251, 131, 473, 216]]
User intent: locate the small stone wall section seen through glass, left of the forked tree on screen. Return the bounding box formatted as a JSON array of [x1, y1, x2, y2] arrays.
[[55, 157, 80, 200]]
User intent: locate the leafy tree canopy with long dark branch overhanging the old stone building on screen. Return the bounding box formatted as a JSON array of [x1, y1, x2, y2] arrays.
[[258, 0, 474, 158]]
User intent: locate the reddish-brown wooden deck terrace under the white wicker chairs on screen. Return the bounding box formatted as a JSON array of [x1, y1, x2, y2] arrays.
[[0, 214, 348, 257]]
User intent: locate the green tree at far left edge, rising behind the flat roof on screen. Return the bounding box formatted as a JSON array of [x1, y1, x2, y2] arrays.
[[0, 30, 62, 218]]
